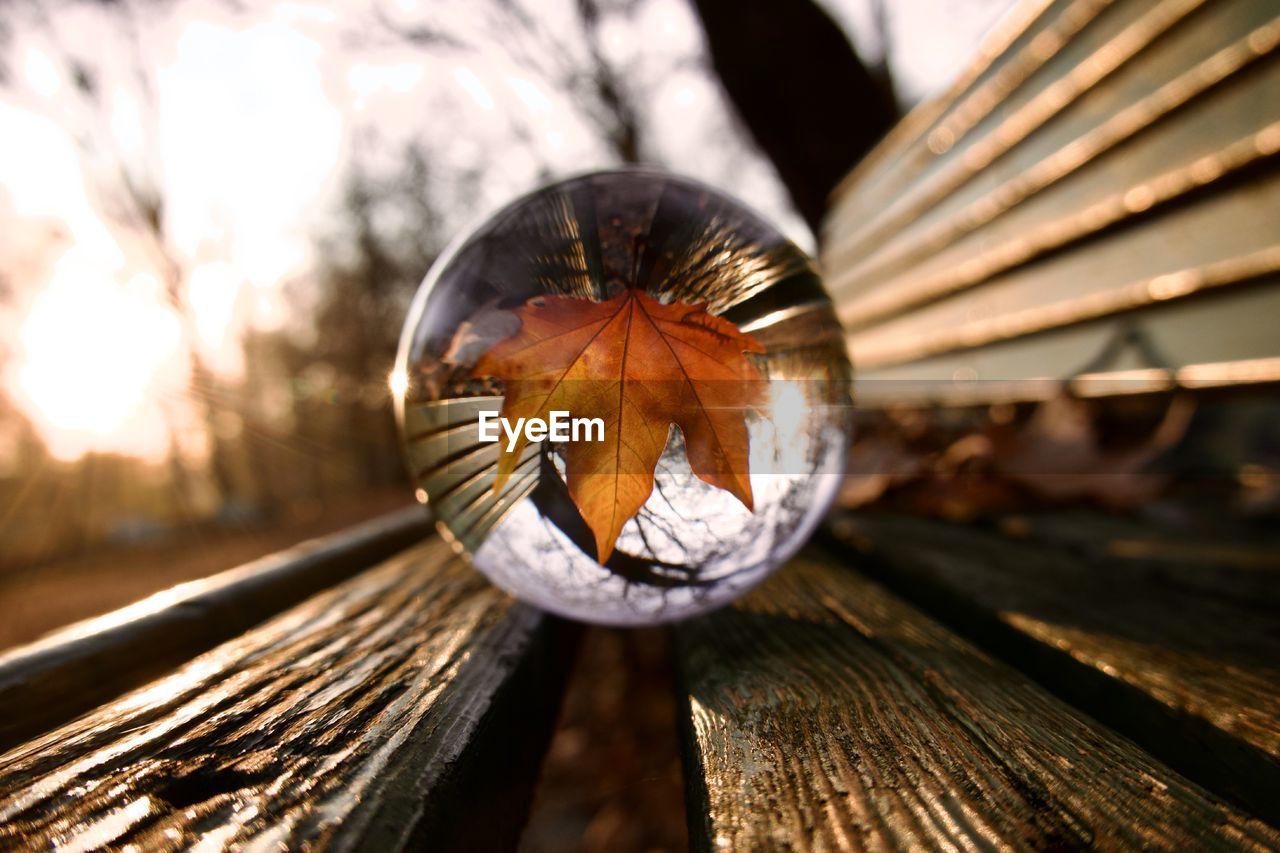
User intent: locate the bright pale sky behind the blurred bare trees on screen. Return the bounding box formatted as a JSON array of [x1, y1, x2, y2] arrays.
[[0, 0, 1009, 474]]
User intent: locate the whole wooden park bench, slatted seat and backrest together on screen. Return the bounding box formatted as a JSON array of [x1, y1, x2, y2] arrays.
[[0, 0, 1280, 850]]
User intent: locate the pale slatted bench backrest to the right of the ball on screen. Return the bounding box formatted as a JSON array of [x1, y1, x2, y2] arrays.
[[822, 0, 1280, 407]]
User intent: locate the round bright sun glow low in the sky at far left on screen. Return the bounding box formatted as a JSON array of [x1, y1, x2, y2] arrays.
[[14, 252, 186, 460]]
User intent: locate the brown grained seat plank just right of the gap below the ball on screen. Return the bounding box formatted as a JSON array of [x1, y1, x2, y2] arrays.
[[676, 556, 1280, 850]]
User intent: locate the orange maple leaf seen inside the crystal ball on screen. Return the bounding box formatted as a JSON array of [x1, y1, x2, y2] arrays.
[[474, 289, 765, 564]]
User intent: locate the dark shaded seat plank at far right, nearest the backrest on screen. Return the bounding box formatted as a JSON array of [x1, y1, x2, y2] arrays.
[[832, 515, 1280, 824]]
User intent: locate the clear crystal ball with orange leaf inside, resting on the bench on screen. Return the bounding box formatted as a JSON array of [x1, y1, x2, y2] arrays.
[[393, 169, 852, 625]]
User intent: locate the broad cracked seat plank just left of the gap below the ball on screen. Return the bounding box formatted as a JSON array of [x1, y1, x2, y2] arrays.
[[0, 540, 567, 850]]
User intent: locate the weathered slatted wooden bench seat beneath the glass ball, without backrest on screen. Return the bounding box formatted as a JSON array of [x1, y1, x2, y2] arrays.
[[0, 507, 1280, 849]]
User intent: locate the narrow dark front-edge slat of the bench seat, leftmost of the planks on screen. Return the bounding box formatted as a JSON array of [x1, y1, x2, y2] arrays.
[[0, 507, 431, 749]]
